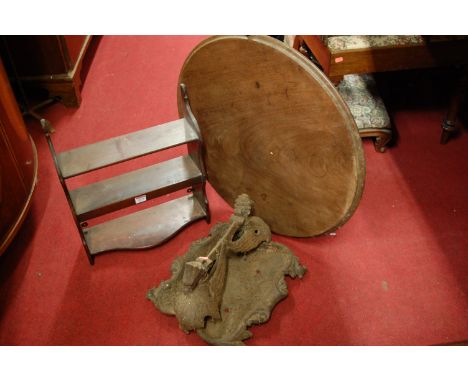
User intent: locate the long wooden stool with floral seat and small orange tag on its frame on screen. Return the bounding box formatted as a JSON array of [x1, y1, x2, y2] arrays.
[[292, 35, 468, 145]]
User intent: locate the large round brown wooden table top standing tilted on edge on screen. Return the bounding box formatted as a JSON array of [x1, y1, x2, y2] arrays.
[[179, 36, 365, 237]]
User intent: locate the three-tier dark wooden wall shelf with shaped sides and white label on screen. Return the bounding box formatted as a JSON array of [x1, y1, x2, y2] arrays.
[[45, 84, 210, 264]]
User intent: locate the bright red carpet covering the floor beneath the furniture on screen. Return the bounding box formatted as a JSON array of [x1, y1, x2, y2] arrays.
[[0, 36, 468, 345]]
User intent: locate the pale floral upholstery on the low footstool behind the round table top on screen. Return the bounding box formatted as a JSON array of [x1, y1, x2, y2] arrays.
[[338, 74, 390, 129]]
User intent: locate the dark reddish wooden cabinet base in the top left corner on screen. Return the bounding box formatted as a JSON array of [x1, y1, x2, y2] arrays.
[[1, 36, 91, 107]]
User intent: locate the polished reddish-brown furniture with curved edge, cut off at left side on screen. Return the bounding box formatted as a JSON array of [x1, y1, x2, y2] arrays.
[[0, 60, 37, 255]]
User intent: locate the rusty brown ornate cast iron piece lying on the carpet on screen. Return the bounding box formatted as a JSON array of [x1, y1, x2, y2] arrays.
[[147, 194, 306, 345]]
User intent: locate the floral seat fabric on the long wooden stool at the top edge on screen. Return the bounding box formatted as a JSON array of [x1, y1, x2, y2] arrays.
[[322, 35, 425, 53]]
